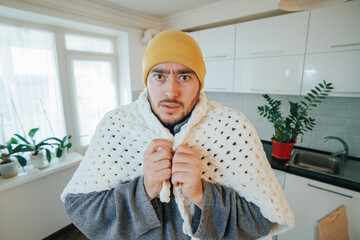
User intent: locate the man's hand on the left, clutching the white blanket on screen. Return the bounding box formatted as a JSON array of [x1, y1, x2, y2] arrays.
[[144, 139, 173, 200]]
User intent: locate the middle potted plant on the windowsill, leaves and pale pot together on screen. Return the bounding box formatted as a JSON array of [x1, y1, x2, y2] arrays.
[[15, 128, 52, 169]]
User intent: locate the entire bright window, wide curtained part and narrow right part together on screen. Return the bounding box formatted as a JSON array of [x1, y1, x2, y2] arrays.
[[0, 23, 119, 153]]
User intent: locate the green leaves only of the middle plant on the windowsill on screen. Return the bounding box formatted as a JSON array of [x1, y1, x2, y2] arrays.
[[14, 128, 54, 162]]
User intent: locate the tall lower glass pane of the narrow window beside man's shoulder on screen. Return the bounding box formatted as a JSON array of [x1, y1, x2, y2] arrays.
[[72, 59, 117, 146]]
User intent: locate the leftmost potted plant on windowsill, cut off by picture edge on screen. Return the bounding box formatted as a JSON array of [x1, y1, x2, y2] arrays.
[[0, 138, 26, 178]]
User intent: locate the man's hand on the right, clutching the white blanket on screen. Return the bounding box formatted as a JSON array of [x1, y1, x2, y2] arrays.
[[171, 144, 203, 208]]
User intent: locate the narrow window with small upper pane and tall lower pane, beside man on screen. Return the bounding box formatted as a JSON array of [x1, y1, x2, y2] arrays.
[[65, 34, 118, 147]]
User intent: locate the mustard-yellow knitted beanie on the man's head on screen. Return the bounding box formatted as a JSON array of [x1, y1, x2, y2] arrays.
[[142, 30, 206, 90]]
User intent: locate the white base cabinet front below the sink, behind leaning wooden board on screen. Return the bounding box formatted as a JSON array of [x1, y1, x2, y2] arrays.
[[278, 173, 360, 240]]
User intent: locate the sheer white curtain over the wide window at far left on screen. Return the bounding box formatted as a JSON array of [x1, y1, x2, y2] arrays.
[[0, 24, 65, 143]]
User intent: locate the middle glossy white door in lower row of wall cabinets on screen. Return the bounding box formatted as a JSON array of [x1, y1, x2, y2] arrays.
[[234, 55, 304, 95]]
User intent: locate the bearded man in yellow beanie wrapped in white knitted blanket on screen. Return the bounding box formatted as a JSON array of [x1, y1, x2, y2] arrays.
[[61, 30, 294, 239]]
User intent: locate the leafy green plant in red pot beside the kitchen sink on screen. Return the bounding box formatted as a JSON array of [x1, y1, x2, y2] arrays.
[[258, 80, 334, 159]]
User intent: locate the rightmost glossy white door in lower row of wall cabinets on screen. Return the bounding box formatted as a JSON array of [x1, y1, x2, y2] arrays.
[[301, 50, 360, 97]]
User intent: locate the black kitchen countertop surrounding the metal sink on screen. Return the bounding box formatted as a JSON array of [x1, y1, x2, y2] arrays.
[[262, 140, 360, 192]]
